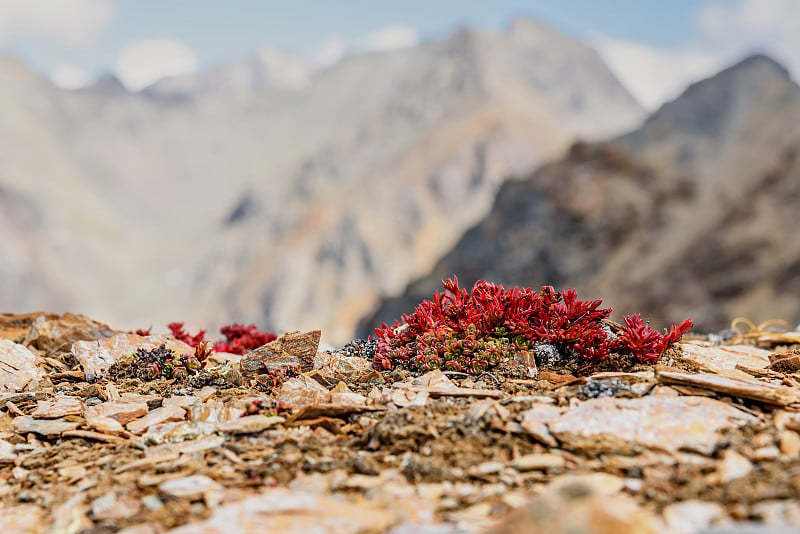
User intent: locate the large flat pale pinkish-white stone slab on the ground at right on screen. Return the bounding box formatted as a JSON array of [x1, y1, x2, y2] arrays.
[[547, 397, 757, 455]]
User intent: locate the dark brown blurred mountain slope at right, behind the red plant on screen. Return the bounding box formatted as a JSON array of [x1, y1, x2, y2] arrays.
[[360, 56, 800, 334]]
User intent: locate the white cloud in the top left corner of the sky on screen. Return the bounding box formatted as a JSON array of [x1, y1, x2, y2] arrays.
[[0, 0, 114, 49]]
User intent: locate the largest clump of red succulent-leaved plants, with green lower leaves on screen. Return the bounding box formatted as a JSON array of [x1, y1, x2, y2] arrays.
[[373, 276, 692, 374]]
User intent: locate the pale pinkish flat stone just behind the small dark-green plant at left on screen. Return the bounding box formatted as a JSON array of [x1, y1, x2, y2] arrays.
[[72, 334, 194, 377]]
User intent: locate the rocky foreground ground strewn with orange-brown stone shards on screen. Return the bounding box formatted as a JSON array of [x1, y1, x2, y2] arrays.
[[0, 314, 800, 534]]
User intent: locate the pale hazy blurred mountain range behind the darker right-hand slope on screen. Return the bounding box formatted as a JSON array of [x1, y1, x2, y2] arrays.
[[0, 20, 643, 342]]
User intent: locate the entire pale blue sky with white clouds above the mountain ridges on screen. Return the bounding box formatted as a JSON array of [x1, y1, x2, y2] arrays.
[[0, 0, 800, 106]]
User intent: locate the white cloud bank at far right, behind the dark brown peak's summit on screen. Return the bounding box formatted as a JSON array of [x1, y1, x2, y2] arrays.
[[590, 0, 800, 109]]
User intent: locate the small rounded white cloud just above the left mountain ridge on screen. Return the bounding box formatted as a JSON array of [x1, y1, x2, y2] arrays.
[[114, 38, 197, 91]]
